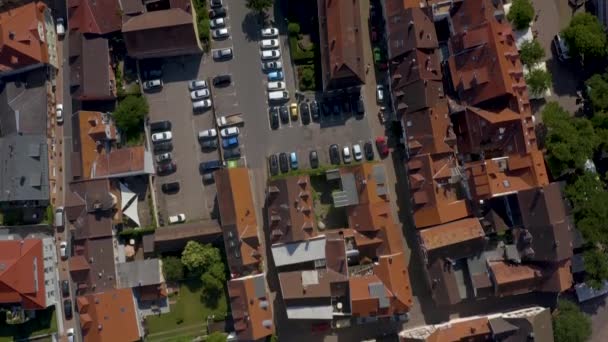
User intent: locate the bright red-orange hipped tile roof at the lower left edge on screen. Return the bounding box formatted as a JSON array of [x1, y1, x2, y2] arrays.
[[0, 239, 47, 310]]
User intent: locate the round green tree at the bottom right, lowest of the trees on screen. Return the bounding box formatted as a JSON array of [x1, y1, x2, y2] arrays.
[[553, 300, 591, 342]]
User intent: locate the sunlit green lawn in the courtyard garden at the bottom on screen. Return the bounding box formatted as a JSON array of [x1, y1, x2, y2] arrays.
[[146, 280, 228, 337]]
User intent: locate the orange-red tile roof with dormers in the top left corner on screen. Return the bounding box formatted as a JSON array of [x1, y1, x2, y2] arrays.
[[0, 2, 49, 73]]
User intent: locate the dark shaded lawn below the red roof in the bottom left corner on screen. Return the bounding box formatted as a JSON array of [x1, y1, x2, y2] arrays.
[[0, 306, 57, 342]]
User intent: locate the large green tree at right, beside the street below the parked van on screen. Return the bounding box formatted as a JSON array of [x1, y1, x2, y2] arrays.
[[542, 102, 599, 177]]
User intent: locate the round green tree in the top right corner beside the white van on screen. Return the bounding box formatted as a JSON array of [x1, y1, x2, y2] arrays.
[[562, 12, 606, 60]]
